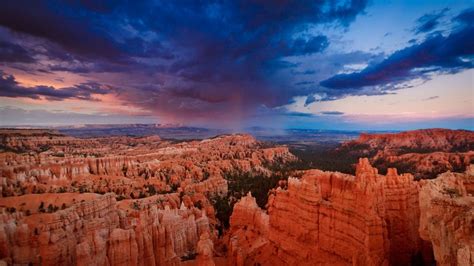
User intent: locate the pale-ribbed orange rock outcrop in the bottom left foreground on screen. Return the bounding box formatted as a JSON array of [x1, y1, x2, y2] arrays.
[[0, 194, 209, 265]]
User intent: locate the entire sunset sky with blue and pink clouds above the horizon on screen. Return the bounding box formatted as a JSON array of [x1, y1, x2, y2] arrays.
[[0, 0, 474, 130]]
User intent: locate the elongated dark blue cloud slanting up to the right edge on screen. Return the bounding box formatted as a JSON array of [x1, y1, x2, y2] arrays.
[[320, 8, 474, 98]]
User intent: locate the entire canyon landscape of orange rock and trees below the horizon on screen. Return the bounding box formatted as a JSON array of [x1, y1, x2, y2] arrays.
[[0, 127, 474, 265]]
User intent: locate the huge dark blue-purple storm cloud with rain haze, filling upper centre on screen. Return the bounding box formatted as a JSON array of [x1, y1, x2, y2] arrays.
[[0, 0, 367, 122]]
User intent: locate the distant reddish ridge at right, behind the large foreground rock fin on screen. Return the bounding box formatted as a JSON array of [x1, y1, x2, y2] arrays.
[[340, 129, 474, 178]]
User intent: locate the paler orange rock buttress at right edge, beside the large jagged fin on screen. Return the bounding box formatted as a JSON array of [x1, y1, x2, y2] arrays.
[[420, 166, 474, 265]]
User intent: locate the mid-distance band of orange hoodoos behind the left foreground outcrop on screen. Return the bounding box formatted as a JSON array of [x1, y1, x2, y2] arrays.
[[0, 132, 295, 198]]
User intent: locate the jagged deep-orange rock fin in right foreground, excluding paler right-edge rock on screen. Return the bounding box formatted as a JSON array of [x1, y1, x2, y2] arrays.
[[229, 159, 429, 265]]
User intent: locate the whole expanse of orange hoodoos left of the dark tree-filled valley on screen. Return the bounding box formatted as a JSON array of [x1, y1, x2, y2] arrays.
[[0, 130, 295, 265]]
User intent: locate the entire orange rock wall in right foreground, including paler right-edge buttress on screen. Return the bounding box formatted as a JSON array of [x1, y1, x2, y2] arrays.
[[228, 159, 474, 265]]
